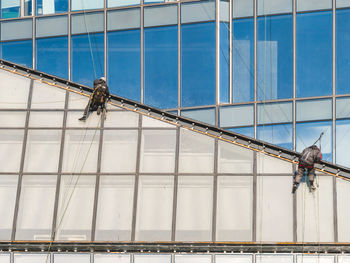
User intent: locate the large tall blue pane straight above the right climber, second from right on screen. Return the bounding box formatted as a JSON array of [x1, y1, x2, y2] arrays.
[[296, 11, 332, 97]]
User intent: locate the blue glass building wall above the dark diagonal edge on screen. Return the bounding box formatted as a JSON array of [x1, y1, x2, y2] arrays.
[[1, 0, 350, 166]]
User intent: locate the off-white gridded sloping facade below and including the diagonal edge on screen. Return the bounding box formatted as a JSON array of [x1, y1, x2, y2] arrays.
[[0, 58, 350, 254]]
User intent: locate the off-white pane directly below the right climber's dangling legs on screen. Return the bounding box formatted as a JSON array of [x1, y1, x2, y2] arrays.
[[296, 176, 334, 243]]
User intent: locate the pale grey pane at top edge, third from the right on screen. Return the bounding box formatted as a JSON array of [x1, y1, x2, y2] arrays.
[[257, 0, 293, 15]]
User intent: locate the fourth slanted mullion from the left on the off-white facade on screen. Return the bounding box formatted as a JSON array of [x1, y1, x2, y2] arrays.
[[131, 115, 142, 241]]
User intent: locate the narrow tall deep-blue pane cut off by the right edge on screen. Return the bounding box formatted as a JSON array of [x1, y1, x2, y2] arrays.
[[336, 9, 350, 94]]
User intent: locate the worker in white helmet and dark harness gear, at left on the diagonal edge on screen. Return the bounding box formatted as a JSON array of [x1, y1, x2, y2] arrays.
[[79, 77, 109, 121]]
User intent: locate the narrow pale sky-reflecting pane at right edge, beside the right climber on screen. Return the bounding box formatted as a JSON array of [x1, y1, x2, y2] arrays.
[[335, 120, 350, 167]]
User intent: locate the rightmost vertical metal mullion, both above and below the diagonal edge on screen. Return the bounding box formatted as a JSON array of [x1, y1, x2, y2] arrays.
[[332, 0, 338, 242]]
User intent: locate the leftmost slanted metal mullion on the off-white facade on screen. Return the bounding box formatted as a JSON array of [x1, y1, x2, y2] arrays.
[[11, 79, 34, 240]]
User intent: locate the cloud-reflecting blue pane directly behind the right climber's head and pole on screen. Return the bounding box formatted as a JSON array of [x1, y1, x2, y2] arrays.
[[296, 121, 333, 162]]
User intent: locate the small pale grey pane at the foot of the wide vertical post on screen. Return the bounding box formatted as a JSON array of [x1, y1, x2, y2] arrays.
[[220, 105, 254, 127]]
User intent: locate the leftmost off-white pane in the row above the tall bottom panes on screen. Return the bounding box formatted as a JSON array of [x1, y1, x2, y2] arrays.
[[0, 130, 24, 172]]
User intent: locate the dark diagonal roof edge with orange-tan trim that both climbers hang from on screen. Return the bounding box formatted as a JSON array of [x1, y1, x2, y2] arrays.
[[0, 59, 350, 181]]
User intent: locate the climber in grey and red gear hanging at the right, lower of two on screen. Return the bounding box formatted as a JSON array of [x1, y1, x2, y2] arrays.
[[292, 144, 322, 194]]
